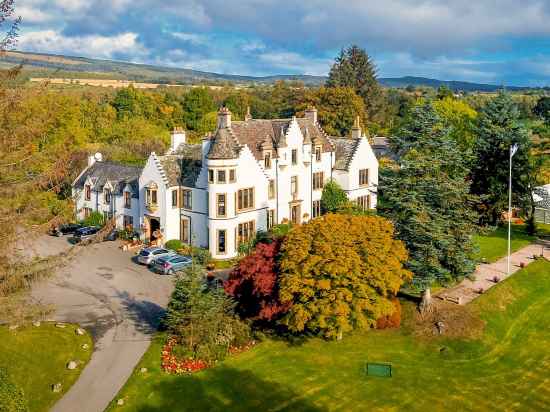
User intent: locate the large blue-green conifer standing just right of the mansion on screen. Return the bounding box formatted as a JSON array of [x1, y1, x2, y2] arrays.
[[379, 102, 475, 298]]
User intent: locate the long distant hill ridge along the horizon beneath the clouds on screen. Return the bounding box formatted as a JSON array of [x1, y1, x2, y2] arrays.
[[0, 51, 527, 92]]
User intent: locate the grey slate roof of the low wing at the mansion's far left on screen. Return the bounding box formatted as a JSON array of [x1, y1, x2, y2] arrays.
[[74, 161, 142, 197]]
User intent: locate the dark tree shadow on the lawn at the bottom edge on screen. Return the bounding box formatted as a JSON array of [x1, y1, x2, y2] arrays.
[[137, 366, 326, 412]]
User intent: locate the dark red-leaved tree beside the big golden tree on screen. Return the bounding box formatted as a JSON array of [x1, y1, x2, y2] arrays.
[[224, 239, 290, 322]]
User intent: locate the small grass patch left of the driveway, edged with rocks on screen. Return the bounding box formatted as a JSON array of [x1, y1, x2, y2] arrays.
[[0, 323, 93, 412]]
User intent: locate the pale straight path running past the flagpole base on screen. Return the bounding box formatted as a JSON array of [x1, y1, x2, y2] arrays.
[[436, 241, 550, 305]]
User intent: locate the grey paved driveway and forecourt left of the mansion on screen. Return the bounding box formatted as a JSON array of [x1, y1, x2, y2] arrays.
[[32, 238, 172, 412]]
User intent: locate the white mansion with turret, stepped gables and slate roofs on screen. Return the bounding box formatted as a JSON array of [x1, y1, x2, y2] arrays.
[[73, 108, 378, 259]]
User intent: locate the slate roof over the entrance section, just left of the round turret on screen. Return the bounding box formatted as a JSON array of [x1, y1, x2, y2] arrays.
[[158, 143, 202, 187]]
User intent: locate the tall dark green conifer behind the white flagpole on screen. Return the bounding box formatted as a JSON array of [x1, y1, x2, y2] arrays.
[[471, 93, 534, 225]]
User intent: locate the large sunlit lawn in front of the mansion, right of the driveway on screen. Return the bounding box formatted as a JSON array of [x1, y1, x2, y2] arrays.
[[111, 260, 550, 412]]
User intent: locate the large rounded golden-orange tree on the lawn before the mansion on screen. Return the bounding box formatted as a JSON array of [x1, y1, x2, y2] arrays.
[[279, 214, 411, 339]]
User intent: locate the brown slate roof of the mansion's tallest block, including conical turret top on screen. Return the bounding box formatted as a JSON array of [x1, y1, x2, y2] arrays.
[[207, 118, 332, 160]]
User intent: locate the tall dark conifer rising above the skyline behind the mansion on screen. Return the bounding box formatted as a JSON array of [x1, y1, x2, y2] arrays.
[[326, 45, 385, 120]]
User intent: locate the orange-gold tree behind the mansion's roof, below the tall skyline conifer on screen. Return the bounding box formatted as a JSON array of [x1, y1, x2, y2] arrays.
[[298, 87, 366, 136]]
